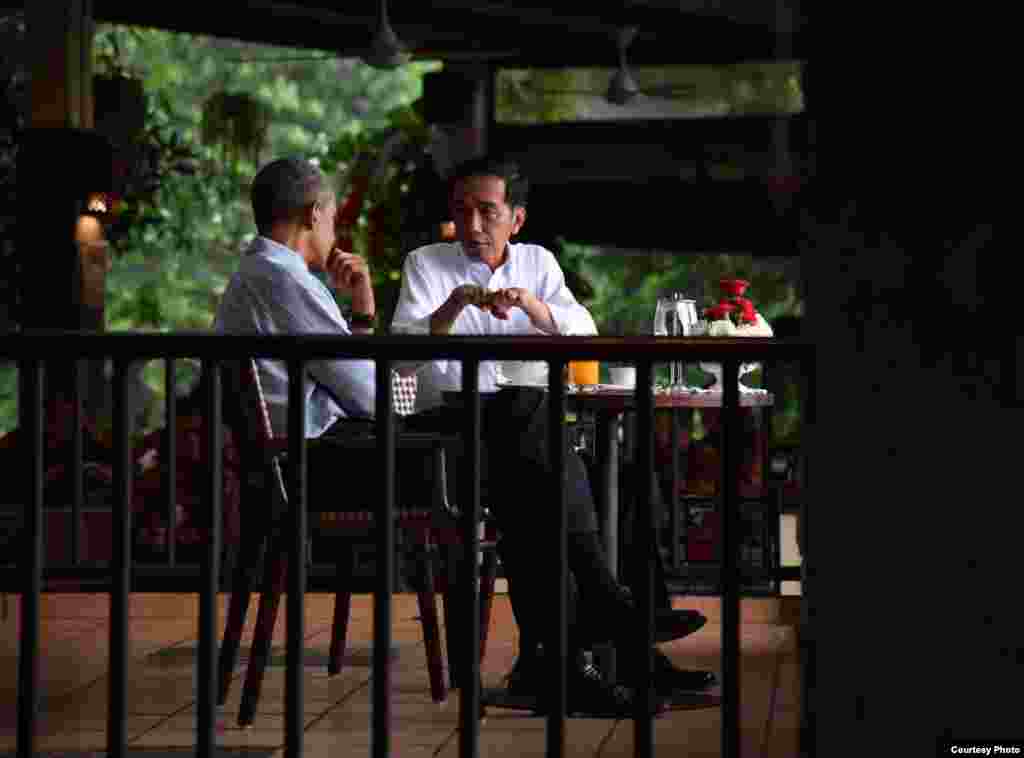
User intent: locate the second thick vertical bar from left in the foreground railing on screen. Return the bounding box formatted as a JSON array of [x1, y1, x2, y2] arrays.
[[106, 359, 132, 758]]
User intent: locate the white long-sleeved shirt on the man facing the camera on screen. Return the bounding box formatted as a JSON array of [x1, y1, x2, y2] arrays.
[[391, 243, 597, 411]]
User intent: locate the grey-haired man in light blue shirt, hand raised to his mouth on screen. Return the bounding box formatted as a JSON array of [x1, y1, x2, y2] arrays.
[[214, 158, 376, 437]]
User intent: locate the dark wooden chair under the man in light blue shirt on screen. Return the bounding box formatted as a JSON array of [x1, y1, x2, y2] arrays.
[[218, 360, 496, 726]]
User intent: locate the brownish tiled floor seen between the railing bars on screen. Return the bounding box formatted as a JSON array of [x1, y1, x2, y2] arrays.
[[0, 594, 799, 758]]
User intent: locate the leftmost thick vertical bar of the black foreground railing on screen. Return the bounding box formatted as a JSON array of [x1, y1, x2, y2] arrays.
[[17, 360, 45, 758]]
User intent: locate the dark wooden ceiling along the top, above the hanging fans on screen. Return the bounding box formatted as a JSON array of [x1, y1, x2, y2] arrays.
[[93, 0, 805, 66]]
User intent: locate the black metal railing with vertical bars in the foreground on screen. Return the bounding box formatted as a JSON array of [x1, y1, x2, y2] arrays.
[[0, 333, 814, 758]]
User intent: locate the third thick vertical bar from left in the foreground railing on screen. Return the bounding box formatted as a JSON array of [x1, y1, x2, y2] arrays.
[[196, 361, 223, 758]]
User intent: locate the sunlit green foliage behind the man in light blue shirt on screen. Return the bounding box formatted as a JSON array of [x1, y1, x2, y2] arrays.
[[94, 26, 436, 340]]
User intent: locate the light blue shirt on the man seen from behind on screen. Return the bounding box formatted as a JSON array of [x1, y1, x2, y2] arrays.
[[214, 237, 376, 437]]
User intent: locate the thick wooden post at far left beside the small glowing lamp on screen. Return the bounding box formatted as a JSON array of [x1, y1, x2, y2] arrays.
[[17, 0, 113, 413]]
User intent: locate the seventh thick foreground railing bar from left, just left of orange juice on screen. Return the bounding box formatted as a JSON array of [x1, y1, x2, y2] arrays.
[[545, 360, 568, 758]]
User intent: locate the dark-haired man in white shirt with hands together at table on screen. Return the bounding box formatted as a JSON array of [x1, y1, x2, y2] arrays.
[[392, 157, 710, 715]]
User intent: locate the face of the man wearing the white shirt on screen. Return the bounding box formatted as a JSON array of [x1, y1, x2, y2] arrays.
[[452, 176, 526, 268]]
